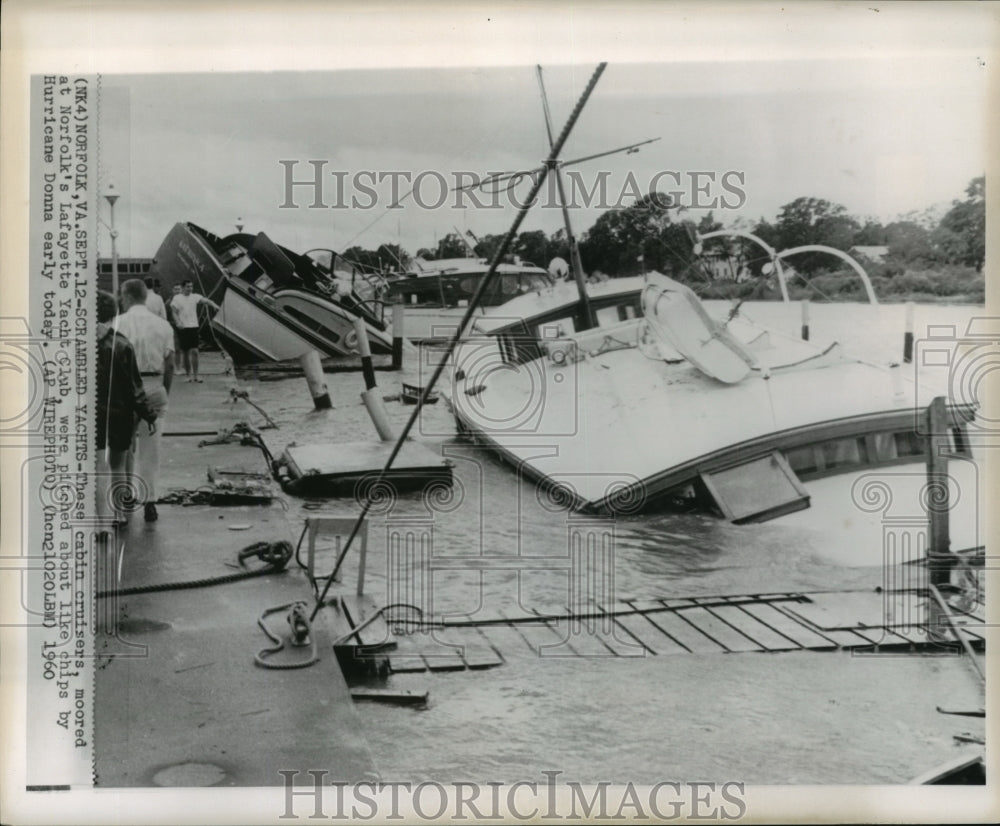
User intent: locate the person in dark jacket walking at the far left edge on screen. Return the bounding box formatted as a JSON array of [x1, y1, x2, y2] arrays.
[[97, 291, 156, 524]]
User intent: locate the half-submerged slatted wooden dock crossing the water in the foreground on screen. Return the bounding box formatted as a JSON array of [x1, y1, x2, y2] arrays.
[[348, 589, 986, 672]]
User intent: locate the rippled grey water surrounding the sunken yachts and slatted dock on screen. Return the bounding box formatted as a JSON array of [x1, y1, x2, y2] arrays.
[[246, 304, 984, 784]]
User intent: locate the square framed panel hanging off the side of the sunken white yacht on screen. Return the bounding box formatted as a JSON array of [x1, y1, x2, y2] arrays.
[[701, 451, 809, 524]]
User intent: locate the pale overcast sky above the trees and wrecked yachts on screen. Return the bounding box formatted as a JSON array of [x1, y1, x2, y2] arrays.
[[92, 6, 992, 256]]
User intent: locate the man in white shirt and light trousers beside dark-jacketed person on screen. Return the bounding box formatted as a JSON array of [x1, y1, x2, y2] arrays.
[[115, 278, 174, 522]]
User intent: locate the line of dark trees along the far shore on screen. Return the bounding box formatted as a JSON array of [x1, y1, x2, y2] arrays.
[[343, 176, 986, 281]]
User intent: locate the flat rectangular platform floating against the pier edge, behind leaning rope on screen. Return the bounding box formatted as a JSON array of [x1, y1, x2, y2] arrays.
[[278, 440, 452, 496]]
